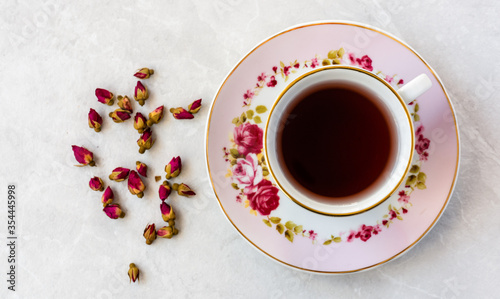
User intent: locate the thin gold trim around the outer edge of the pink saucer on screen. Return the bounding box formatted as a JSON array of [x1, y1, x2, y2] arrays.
[[205, 21, 460, 274]]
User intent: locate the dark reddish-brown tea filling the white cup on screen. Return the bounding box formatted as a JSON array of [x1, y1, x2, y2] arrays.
[[277, 87, 392, 197]]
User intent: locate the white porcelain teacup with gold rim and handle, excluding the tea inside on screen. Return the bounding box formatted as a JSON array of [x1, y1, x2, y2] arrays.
[[264, 66, 431, 216]]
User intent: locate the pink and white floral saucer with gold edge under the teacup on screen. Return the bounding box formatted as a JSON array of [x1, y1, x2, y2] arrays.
[[205, 21, 460, 274]]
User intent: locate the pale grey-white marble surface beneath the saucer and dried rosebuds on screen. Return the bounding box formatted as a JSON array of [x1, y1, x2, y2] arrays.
[[0, 0, 500, 298]]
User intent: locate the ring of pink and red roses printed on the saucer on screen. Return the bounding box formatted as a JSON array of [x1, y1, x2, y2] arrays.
[[224, 49, 430, 245]]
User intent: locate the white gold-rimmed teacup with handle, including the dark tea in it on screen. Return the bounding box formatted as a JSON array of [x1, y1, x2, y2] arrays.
[[264, 66, 431, 216]]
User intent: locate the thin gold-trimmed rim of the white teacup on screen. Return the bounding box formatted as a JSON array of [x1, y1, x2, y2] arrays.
[[264, 65, 415, 216]]
